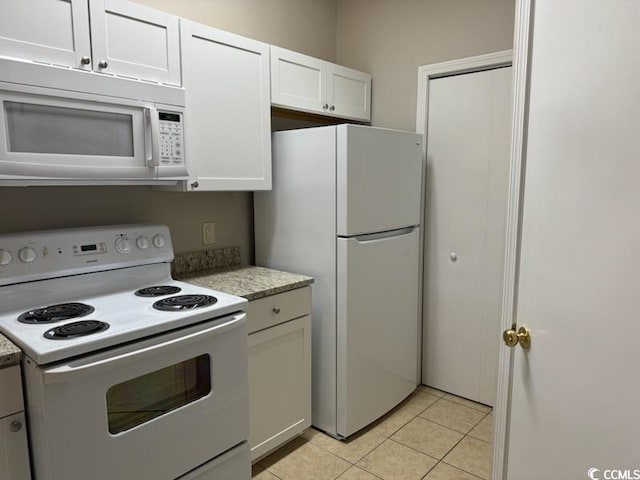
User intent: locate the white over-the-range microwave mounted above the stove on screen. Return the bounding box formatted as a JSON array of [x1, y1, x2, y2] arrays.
[[0, 82, 188, 186]]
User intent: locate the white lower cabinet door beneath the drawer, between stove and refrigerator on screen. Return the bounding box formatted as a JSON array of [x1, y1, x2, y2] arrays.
[[249, 315, 311, 460]]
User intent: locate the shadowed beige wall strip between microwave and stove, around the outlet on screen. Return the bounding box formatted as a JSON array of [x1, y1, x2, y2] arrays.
[[0, 187, 253, 263]]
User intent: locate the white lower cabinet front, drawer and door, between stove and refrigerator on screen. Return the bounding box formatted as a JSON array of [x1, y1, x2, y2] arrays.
[[248, 287, 311, 461]]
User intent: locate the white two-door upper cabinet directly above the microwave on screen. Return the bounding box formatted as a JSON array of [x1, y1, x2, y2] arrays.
[[0, 0, 181, 85]]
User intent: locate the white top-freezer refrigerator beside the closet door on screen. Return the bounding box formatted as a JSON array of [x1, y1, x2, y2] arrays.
[[254, 125, 422, 438]]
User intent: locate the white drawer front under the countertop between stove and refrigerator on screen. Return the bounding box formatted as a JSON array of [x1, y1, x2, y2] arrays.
[[247, 287, 311, 333]]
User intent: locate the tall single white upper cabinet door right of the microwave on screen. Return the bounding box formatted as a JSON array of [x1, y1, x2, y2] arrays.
[[181, 21, 271, 191]]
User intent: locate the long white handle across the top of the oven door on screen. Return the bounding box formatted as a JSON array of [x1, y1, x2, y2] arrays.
[[43, 312, 246, 385]]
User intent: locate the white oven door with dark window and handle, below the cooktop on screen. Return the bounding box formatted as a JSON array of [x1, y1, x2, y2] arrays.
[[24, 312, 249, 480]]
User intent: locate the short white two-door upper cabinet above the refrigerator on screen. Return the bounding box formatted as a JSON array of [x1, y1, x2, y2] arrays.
[[271, 46, 371, 122]]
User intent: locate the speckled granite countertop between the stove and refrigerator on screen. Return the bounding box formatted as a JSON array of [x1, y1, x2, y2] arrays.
[[176, 266, 313, 300]]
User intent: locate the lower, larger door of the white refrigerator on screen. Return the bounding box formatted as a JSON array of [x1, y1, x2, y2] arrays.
[[336, 228, 420, 437]]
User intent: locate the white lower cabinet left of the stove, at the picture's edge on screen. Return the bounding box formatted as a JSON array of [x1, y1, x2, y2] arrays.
[[0, 365, 31, 480]]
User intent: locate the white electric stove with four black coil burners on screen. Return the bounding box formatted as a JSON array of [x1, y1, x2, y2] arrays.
[[0, 225, 251, 480]]
